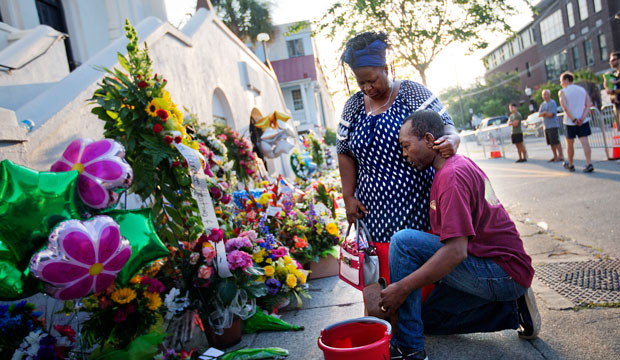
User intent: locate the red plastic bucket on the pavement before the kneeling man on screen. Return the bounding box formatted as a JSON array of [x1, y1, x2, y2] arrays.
[[318, 316, 392, 360]]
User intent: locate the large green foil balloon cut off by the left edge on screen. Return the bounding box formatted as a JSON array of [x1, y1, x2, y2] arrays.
[[0, 160, 81, 300]]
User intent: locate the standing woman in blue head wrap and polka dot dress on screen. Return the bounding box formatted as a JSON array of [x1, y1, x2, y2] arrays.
[[337, 32, 460, 281]]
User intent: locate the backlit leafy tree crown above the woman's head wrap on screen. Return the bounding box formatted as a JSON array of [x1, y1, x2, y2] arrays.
[[317, 0, 529, 85]]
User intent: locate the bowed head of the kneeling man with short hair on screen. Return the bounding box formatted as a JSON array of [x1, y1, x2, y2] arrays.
[[398, 110, 444, 170]]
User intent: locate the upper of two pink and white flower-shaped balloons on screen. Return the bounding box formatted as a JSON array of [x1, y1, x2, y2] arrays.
[[51, 139, 133, 209]]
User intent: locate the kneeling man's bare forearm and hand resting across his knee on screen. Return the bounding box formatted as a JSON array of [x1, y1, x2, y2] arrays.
[[379, 236, 468, 317]]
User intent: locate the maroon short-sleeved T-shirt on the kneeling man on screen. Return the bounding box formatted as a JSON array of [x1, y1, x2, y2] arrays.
[[430, 155, 534, 288]]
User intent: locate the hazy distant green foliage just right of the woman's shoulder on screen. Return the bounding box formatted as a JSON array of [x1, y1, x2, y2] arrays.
[[439, 73, 529, 127]]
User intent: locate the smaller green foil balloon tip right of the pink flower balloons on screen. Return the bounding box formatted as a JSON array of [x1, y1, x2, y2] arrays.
[[102, 209, 169, 286]]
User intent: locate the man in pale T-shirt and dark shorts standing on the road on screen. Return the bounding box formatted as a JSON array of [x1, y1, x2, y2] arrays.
[[558, 72, 594, 172]]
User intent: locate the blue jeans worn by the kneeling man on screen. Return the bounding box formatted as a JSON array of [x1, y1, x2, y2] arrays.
[[390, 230, 527, 350]]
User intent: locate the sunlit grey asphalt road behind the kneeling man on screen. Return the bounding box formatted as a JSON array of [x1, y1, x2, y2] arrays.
[[459, 137, 620, 258]]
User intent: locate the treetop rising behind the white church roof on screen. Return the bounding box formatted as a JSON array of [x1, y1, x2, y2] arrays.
[[208, 0, 273, 44]]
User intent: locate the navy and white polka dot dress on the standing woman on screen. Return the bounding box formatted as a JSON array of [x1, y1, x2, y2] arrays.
[[337, 81, 452, 243]]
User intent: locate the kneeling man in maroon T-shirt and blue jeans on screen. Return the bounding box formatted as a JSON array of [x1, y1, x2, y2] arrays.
[[380, 110, 540, 359]]
